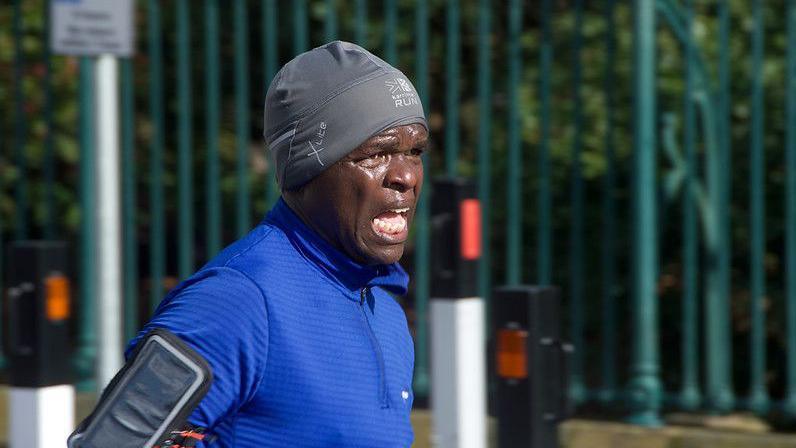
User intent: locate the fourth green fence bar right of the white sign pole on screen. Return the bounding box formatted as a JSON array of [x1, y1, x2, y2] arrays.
[[204, 0, 221, 258]]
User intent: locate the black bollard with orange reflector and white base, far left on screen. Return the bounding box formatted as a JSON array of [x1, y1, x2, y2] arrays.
[[3, 241, 75, 448]]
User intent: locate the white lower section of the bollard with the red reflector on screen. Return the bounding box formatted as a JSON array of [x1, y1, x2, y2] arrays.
[[431, 297, 487, 448]]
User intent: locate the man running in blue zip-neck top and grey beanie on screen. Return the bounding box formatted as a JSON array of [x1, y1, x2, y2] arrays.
[[131, 42, 428, 447]]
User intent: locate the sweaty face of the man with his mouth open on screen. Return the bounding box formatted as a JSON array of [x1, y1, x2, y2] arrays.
[[286, 124, 428, 264]]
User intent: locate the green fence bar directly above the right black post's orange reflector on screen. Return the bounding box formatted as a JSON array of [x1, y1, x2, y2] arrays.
[[506, 0, 522, 285]]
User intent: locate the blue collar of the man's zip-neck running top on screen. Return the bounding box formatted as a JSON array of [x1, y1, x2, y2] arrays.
[[266, 198, 409, 295]]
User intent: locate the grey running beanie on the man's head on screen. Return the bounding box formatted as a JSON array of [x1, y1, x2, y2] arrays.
[[263, 41, 428, 191]]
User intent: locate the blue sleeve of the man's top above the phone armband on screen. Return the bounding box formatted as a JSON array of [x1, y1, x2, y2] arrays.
[[127, 267, 268, 432]]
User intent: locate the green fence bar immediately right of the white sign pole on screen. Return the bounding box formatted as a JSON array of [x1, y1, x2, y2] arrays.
[[120, 59, 138, 340]]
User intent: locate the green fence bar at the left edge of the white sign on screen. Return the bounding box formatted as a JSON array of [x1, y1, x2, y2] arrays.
[[43, 0, 55, 240]]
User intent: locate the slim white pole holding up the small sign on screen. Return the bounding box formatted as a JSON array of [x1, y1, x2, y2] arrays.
[[95, 55, 123, 392]]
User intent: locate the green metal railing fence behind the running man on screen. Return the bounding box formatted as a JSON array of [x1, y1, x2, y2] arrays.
[[0, 0, 796, 425]]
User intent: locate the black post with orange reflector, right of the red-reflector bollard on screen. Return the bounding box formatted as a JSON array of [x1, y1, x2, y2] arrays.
[[492, 286, 572, 448]]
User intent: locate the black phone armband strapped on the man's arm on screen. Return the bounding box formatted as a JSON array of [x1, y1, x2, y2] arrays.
[[67, 328, 213, 448]]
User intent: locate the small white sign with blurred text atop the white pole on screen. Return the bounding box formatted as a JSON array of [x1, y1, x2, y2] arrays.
[[50, 0, 134, 56]]
